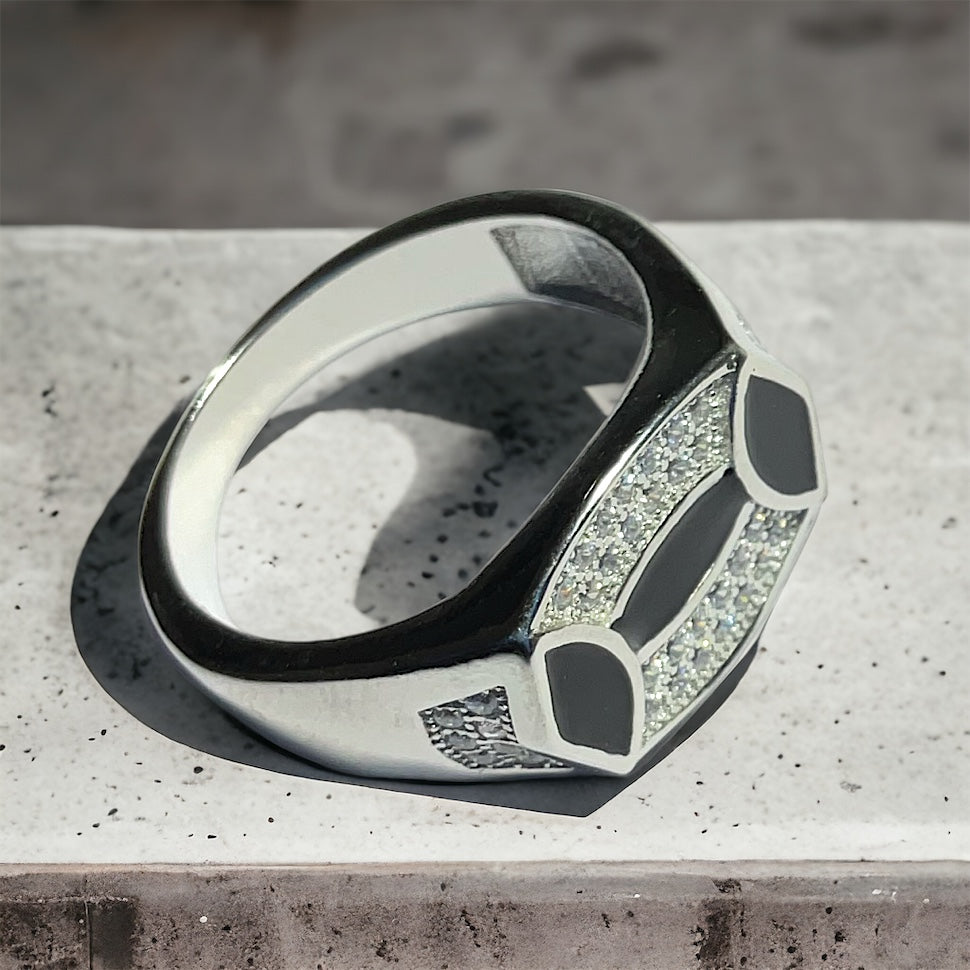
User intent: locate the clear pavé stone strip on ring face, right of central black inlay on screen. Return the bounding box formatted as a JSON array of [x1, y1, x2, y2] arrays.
[[643, 505, 805, 741]]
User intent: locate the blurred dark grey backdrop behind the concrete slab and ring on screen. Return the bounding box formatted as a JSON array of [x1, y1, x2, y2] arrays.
[[0, 0, 970, 227]]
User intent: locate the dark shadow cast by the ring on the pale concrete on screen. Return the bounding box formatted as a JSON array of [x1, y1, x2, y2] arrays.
[[71, 300, 720, 816]]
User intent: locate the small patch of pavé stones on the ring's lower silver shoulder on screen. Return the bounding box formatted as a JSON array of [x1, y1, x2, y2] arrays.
[[421, 687, 568, 768]]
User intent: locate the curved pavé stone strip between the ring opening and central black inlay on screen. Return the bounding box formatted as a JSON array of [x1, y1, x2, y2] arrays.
[[534, 364, 734, 633]]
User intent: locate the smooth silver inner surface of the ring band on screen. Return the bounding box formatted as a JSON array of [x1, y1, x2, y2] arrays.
[[158, 217, 650, 624]]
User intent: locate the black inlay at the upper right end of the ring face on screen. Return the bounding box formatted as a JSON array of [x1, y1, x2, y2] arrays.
[[744, 377, 818, 495]]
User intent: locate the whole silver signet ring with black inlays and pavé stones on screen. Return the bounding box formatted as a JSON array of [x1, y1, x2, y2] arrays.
[[139, 191, 825, 781]]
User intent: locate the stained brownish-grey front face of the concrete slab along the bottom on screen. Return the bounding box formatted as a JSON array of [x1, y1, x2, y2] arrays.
[[0, 864, 970, 970]]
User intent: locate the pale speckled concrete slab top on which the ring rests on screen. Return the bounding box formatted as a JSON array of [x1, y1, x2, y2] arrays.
[[0, 223, 970, 872]]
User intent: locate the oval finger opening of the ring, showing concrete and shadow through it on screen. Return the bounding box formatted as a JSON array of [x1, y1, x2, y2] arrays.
[[219, 302, 643, 639]]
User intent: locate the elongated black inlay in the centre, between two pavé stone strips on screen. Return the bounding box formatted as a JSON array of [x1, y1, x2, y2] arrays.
[[613, 472, 748, 649]]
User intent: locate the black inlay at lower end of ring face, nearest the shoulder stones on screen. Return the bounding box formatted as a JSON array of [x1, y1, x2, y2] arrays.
[[546, 643, 633, 754]]
